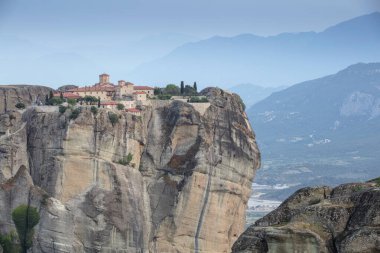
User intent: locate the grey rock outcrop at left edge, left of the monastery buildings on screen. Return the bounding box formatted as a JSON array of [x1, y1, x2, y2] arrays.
[[0, 85, 52, 114]]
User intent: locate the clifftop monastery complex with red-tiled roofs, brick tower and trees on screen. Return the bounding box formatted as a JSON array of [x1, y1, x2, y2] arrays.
[[41, 74, 208, 115]]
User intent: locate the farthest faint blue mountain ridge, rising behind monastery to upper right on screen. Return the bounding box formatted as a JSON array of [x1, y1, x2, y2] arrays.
[[130, 13, 380, 87]]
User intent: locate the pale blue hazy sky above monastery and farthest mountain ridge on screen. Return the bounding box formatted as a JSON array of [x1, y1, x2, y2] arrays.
[[0, 0, 380, 87]]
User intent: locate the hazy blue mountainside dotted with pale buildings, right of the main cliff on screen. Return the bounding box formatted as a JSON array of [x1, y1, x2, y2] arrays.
[[247, 63, 380, 200]]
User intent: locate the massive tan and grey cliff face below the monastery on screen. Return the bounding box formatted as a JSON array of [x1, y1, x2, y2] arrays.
[[0, 86, 260, 252]]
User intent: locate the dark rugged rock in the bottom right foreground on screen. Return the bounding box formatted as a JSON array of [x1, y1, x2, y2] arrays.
[[232, 178, 380, 253]]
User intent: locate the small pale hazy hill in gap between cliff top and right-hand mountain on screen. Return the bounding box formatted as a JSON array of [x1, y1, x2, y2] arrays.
[[228, 83, 285, 108]]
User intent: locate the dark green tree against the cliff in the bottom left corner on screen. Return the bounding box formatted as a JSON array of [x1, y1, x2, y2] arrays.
[[12, 205, 40, 253]]
